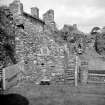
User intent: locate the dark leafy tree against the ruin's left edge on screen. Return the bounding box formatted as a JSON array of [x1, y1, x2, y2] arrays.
[[0, 7, 16, 67]]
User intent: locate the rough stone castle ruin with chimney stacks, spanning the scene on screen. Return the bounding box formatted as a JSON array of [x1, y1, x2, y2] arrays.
[[0, 0, 105, 89]]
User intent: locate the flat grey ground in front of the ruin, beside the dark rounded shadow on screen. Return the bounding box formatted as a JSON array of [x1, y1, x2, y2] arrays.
[[9, 83, 105, 105]]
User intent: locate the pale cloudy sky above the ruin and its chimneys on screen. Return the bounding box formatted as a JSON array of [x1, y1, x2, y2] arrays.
[[0, 0, 105, 33]]
